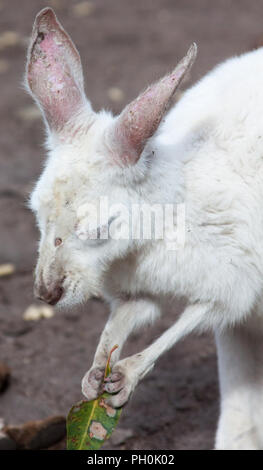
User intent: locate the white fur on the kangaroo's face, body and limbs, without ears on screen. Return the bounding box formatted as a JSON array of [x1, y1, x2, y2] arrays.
[[28, 20, 263, 449]]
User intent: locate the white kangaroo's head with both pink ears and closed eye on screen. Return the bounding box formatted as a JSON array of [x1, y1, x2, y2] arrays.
[[26, 8, 196, 305]]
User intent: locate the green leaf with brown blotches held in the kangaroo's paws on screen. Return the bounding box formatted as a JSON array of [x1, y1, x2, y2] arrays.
[[67, 346, 122, 450]]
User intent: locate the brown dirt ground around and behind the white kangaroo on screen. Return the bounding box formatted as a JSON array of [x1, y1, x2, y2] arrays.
[[0, 0, 263, 449]]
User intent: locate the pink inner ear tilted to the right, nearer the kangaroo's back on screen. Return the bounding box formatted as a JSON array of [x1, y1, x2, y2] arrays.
[[112, 44, 197, 165]]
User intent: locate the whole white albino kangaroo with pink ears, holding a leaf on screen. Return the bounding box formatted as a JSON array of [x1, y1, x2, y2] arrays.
[[26, 8, 263, 449]]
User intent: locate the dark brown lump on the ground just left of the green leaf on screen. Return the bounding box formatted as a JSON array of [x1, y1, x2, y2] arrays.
[[4, 416, 66, 450]]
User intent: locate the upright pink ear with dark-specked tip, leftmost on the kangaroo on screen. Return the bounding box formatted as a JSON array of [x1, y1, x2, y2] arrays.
[[26, 8, 89, 131]]
